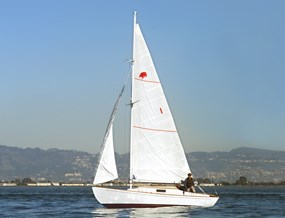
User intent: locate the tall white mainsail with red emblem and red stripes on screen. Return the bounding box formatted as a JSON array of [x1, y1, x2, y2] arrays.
[[130, 18, 190, 183]]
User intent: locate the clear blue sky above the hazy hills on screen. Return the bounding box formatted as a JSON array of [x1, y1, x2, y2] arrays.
[[0, 0, 285, 153]]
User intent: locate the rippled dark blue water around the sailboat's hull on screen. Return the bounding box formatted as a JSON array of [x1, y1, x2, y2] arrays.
[[0, 187, 285, 218]]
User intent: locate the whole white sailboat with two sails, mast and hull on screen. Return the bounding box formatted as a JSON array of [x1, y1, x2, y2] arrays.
[[92, 12, 219, 208]]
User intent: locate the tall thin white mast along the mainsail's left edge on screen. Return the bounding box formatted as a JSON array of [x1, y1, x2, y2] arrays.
[[130, 11, 137, 188]]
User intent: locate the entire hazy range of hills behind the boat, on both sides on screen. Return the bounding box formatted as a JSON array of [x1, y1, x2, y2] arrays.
[[0, 145, 285, 182]]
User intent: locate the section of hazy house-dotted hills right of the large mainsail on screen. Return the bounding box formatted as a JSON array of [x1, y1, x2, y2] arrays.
[[187, 147, 285, 182]]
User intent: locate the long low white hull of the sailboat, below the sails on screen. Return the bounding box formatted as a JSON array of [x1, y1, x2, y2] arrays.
[[92, 187, 219, 208]]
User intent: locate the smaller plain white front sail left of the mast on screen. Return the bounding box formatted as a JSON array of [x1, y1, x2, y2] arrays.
[[93, 86, 125, 184]]
